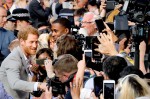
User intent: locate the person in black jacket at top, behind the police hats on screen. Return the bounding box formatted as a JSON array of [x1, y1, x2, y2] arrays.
[[29, 0, 51, 28]]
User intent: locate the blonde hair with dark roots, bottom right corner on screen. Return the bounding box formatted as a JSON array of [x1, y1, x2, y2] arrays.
[[119, 74, 150, 99]]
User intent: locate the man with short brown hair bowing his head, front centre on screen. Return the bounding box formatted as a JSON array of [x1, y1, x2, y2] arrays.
[[53, 54, 81, 99]]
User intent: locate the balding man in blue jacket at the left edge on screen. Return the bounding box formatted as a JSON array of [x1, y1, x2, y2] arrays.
[[0, 7, 16, 65]]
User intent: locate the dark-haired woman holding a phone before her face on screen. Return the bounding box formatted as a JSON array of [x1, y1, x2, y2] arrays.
[[30, 48, 54, 99]]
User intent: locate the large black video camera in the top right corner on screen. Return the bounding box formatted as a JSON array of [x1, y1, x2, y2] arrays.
[[125, 0, 150, 23]]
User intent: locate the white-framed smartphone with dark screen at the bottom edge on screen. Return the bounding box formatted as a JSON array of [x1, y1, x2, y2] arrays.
[[103, 80, 115, 99]]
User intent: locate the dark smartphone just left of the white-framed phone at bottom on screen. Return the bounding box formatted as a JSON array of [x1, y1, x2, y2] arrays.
[[94, 76, 104, 97]]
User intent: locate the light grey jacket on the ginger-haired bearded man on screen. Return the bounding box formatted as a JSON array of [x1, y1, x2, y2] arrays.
[[0, 46, 35, 99]]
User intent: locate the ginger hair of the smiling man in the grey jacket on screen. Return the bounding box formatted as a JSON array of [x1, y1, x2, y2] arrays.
[[18, 25, 39, 40]]
